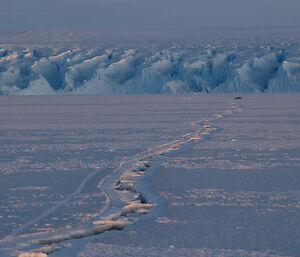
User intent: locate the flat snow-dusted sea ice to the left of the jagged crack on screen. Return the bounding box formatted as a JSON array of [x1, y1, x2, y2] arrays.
[[0, 95, 230, 256]]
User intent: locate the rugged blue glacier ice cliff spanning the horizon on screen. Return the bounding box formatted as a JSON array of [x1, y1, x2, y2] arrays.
[[0, 40, 300, 95]]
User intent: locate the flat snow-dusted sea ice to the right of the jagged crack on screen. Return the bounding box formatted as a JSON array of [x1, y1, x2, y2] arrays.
[[79, 95, 300, 256]]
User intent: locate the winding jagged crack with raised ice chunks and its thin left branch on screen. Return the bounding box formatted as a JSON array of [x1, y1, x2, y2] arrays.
[[0, 98, 243, 257]]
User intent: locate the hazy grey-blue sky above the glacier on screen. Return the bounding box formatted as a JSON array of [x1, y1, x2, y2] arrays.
[[0, 0, 300, 30]]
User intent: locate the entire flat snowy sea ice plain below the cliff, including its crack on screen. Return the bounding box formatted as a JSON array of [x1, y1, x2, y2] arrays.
[[0, 94, 300, 257]]
